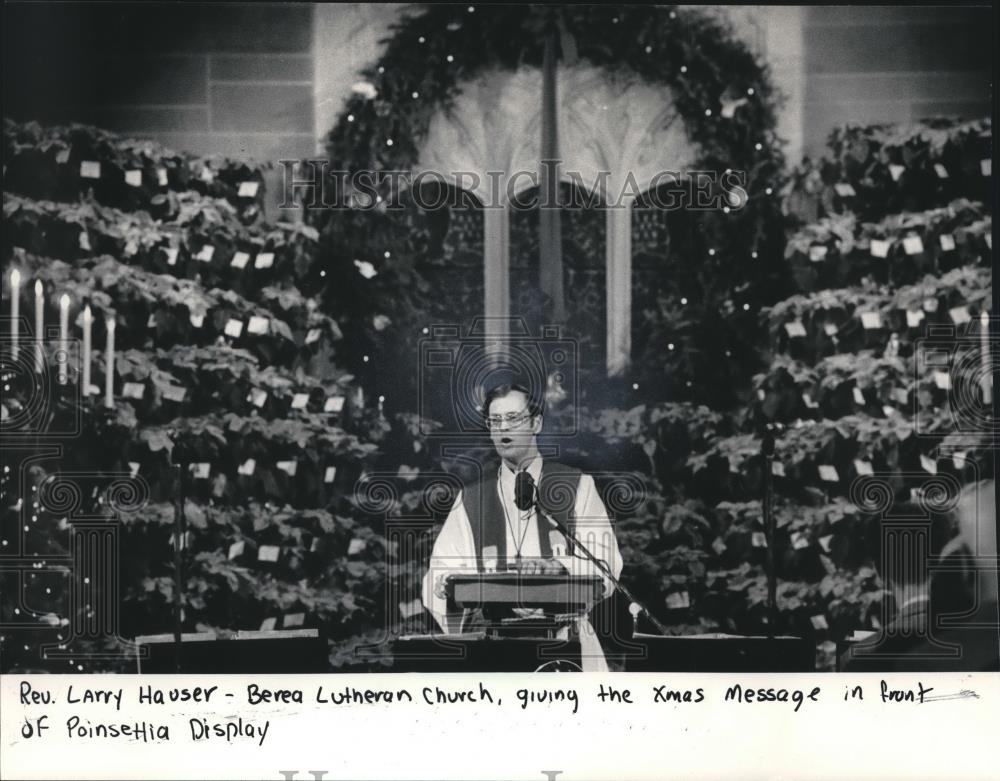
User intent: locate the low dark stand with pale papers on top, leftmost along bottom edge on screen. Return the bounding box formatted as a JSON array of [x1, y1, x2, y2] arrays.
[[135, 629, 330, 675]]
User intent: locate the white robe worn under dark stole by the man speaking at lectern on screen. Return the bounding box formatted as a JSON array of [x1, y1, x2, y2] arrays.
[[423, 456, 622, 671]]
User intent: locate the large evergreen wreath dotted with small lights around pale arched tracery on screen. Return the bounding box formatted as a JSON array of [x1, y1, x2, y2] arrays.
[[310, 4, 784, 408]]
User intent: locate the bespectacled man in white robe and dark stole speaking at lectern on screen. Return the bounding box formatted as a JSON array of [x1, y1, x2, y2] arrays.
[[423, 383, 622, 671]]
